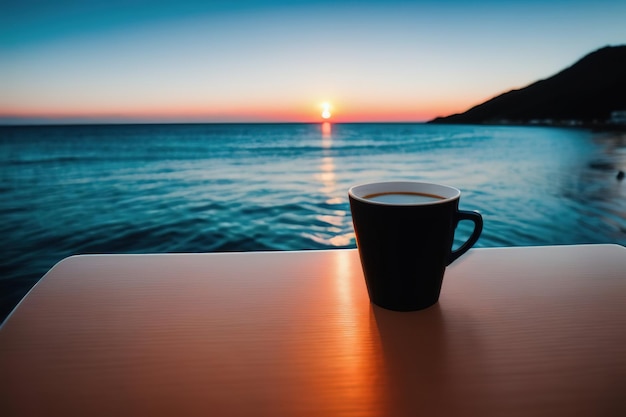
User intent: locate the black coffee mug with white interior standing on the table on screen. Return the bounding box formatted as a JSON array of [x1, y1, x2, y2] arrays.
[[348, 181, 483, 311]]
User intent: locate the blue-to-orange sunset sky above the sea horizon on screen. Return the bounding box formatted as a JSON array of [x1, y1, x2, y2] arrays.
[[0, 0, 626, 124]]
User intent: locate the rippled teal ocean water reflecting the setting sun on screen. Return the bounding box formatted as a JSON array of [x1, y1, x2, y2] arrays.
[[0, 124, 626, 320]]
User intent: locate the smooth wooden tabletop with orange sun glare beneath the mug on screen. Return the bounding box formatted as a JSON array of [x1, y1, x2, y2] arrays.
[[0, 245, 626, 416]]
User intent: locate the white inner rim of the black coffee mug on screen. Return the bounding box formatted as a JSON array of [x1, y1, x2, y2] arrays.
[[348, 181, 461, 206]]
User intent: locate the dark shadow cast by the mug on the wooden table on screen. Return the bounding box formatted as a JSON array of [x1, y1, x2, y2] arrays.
[[370, 303, 484, 416]]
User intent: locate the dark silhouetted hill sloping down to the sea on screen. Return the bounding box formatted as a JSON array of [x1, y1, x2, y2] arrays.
[[429, 45, 626, 125]]
